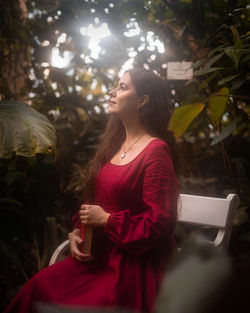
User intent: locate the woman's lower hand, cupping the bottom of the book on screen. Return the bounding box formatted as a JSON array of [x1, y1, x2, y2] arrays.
[[68, 228, 93, 262]]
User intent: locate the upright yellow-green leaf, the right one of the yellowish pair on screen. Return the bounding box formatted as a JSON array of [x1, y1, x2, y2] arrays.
[[208, 87, 229, 124]]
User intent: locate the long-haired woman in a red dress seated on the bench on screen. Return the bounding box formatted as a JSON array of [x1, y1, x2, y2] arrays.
[[5, 69, 178, 313]]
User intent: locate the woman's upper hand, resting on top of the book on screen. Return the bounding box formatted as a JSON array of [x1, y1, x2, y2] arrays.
[[79, 204, 110, 227]]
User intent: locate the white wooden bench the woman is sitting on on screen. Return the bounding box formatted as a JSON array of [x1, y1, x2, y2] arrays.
[[49, 194, 240, 265]]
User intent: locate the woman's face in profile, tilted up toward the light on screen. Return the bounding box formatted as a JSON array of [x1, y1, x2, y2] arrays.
[[108, 72, 139, 117]]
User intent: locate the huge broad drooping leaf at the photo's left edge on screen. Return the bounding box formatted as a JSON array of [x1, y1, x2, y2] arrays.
[[0, 101, 56, 159]]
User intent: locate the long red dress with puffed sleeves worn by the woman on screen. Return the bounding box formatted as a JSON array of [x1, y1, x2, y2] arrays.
[[5, 139, 178, 313]]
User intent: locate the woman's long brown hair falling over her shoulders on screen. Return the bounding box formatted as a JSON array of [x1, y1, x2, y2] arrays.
[[85, 68, 179, 201]]
